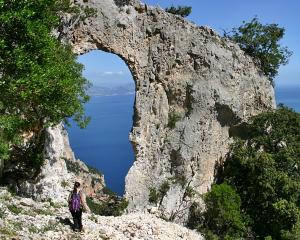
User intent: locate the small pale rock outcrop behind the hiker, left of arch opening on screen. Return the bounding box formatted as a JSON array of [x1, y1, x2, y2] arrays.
[[18, 125, 105, 202]]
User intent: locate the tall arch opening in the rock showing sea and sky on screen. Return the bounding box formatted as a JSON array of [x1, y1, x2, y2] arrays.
[[67, 50, 135, 196]]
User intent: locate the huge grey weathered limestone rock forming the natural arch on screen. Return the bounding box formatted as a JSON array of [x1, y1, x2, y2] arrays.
[[61, 0, 275, 222]]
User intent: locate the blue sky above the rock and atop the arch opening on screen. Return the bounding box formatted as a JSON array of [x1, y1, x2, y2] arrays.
[[79, 0, 300, 87]]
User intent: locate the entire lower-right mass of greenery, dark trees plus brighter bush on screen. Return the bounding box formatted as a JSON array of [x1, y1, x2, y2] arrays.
[[190, 106, 300, 239]]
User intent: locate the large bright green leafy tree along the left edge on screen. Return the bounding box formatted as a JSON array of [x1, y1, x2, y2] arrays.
[[0, 0, 89, 180]]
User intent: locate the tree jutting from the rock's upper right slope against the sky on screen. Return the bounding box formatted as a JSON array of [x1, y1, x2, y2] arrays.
[[224, 18, 292, 82]]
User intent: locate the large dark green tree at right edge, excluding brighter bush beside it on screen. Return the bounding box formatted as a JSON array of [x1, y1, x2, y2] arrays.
[[224, 106, 300, 239]]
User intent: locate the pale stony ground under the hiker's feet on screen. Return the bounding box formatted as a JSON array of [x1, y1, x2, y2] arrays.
[[0, 188, 203, 240]]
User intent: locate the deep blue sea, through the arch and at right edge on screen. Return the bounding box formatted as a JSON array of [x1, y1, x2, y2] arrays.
[[67, 85, 300, 196]]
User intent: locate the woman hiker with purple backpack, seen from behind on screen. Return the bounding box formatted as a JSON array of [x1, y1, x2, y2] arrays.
[[68, 182, 91, 232]]
